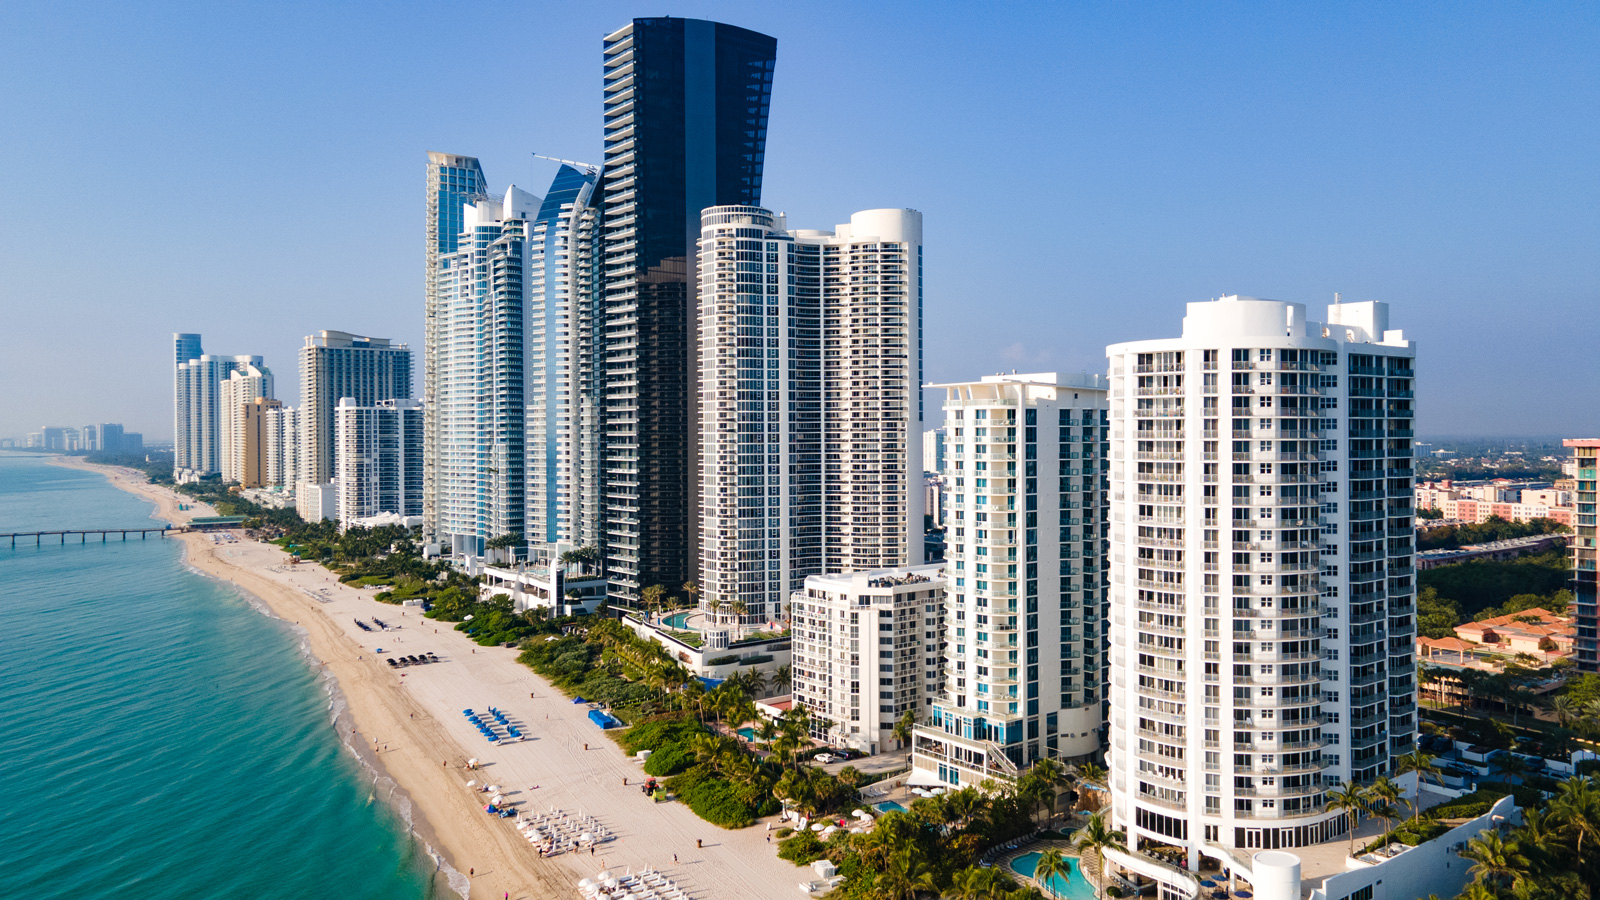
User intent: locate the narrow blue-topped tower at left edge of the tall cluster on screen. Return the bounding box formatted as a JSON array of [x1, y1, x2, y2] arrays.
[[422, 152, 488, 538]]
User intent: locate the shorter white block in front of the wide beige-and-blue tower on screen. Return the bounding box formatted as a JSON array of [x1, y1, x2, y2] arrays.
[[334, 397, 422, 528]]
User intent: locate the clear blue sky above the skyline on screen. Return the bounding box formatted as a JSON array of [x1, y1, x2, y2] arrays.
[[0, 0, 1600, 439]]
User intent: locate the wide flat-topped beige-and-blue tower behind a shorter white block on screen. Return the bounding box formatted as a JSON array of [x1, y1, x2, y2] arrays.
[[299, 331, 414, 482]]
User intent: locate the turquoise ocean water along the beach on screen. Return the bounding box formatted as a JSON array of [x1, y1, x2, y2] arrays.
[[0, 453, 454, 900]]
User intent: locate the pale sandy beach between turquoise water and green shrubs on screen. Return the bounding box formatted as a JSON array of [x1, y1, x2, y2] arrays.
[[61, 460, 811, 900]]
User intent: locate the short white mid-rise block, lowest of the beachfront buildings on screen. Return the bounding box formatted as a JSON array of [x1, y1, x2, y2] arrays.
[[790, 565, 949, 753]]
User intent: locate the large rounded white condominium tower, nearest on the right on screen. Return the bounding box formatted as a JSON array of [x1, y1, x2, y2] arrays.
[[1106, 296, 1416, 871]]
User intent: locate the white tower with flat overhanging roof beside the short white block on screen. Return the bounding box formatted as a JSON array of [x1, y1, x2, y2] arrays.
[[912, 373, 1106, 785]]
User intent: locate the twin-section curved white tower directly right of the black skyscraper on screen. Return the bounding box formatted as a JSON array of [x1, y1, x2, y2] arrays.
[[698, 207, 923, 623]]
